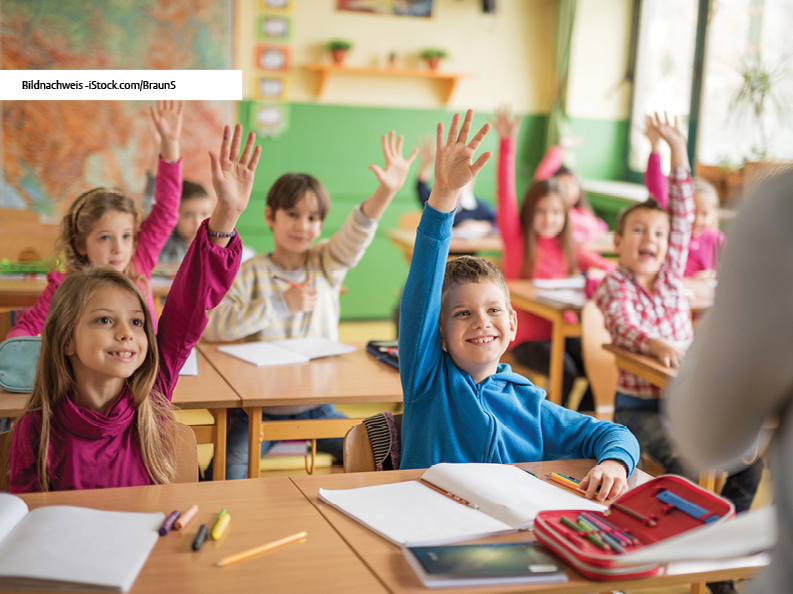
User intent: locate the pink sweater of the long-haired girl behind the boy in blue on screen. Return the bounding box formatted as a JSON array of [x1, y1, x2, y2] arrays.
[[496, 138, 615, 344]]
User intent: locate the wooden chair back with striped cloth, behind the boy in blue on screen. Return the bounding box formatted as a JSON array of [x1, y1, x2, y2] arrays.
[[343, 412, 402, 472]]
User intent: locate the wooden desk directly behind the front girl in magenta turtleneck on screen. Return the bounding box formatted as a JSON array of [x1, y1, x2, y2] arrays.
[[0, 351, 242, 481]]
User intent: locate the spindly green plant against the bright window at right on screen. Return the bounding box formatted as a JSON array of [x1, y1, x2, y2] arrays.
[[730, 55, 785, 159]]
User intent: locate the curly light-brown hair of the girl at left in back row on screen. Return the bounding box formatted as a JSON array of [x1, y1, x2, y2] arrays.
[[55, 188, 148, 286]]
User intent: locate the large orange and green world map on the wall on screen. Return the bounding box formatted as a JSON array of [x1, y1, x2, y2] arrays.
[[0, 0, 236, 218]]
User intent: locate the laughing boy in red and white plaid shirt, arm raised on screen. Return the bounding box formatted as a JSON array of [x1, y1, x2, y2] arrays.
[[595, 114, 763, 592]]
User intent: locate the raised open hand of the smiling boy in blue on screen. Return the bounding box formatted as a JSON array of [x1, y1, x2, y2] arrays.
[[429, 109, 493, 212]]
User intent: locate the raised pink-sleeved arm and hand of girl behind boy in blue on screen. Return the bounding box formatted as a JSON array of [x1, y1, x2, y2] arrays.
[[491, 107, 524, 280]]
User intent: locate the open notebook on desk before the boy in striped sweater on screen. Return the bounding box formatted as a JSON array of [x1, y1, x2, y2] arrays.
[[218, 338, 355, 367]]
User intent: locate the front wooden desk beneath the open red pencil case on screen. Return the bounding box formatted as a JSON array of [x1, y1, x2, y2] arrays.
[[291, 460, 760, 594]]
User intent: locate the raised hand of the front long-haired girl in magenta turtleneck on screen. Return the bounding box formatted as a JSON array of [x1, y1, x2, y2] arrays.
[[209, 124, 262, 231]]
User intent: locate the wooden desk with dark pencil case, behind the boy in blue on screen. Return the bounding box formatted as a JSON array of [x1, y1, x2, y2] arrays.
[[198, 342, 402, 478]]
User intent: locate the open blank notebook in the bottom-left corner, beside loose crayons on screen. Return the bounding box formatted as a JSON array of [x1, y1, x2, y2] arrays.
[[0, 493, 165, 592]]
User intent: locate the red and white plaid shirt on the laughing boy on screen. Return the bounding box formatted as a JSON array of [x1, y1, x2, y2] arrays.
[[595, 168, 694, 398]]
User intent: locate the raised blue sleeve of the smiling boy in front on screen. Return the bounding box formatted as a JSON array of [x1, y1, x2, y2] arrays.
[[399, 205, 454, 401]]
